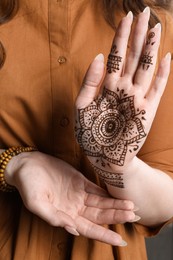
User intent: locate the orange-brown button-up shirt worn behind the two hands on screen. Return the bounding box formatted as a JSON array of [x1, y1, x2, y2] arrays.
[[0, 0, 173, 260]]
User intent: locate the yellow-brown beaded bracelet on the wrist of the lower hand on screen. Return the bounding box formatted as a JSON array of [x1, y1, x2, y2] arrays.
[[0, 146, 37, 192]]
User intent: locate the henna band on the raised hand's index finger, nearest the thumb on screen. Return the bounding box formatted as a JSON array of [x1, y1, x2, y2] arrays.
[[107, 45, 122, 73]]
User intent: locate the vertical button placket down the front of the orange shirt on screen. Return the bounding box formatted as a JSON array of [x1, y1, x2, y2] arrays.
[[49, 0, 74, 156]]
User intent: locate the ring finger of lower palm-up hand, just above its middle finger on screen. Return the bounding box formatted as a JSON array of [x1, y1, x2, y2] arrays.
[[85, 194, 135, 210]]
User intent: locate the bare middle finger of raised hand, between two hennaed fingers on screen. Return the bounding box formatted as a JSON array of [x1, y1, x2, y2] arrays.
[[124, 7, 150, 77]]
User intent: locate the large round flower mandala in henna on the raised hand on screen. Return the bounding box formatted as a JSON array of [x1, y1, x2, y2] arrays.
[[75, 88, 146, 168]]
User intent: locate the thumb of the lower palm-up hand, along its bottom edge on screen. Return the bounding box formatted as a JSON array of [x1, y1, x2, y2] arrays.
[[26, 200, 76, 228]]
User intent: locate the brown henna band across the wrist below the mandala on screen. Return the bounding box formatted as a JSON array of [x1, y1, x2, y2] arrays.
[[92, 165, 125, 189]]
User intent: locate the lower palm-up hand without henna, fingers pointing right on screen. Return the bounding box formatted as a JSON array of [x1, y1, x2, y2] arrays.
[[5, 152, 138, 246]]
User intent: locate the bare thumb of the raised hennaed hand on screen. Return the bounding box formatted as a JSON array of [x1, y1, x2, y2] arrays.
[[76, 54, 104, 109]]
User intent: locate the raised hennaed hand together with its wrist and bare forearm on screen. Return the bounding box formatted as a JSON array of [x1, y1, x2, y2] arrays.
[[76, 8, 173, 226]]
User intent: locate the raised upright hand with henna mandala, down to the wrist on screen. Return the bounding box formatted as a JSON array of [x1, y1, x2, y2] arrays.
[[75, 8, 170, 188]]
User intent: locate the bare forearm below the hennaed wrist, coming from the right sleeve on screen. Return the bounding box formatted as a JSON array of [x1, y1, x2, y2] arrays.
[[107, 158, 173, 226]]
